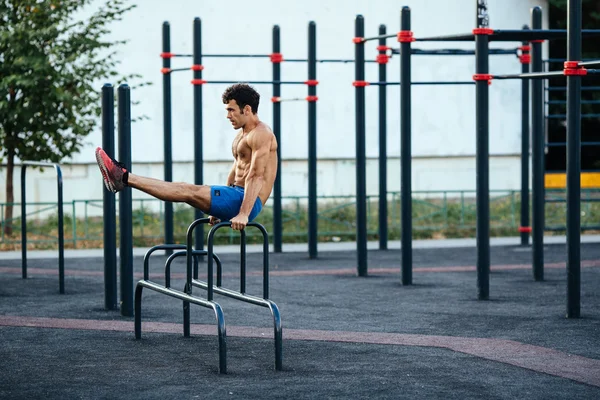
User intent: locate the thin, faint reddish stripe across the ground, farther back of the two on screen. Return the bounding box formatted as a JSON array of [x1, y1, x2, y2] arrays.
[[0, 260, 600, 279]]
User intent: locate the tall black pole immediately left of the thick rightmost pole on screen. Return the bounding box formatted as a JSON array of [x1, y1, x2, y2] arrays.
[[531, 7, 545, 281]]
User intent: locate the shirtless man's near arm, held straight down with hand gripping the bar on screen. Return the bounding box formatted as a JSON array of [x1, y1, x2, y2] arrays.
[[231, 130, 272, 230]]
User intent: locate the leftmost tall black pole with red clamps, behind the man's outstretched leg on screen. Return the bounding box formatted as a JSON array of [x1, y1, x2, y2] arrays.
[[162, 21, 175, 255]]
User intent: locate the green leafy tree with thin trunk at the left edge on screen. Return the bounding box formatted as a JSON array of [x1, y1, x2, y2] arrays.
[[0, 0, 143, 234]]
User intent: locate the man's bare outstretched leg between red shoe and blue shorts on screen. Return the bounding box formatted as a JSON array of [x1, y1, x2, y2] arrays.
[[127, 173, 210, 213]]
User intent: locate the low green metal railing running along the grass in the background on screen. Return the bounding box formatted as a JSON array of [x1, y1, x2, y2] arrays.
[[0, 189, 600, 248]]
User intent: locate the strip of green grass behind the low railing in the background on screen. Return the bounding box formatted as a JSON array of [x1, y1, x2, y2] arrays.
[[0, 191, 600, 250]]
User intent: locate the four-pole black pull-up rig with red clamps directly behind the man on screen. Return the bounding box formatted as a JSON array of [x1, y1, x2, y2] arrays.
[[161, 18, 390, 258]]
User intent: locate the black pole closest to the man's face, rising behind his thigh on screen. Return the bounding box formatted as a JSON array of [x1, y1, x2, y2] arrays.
[[194, 17, 204, 250]]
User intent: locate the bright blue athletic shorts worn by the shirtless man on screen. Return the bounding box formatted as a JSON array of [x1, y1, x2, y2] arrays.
[[209, 186, 262, 222]]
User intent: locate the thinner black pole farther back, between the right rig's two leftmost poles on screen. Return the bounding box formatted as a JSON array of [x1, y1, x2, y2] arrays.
[[379, 25, 388, 250]]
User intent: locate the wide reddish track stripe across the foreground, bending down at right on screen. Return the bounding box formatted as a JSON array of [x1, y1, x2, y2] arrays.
[[0, 316, 600, 387]]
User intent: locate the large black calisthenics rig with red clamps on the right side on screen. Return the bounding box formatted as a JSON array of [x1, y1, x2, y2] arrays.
[[354, 0, 600, 318]]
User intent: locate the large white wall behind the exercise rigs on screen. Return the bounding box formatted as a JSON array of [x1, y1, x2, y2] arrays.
[[0, 0, 547, 212]]
